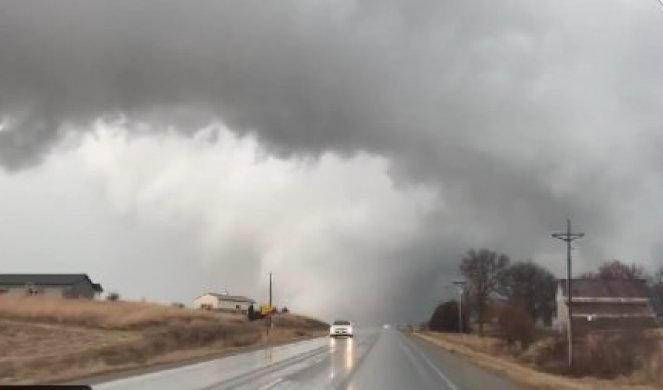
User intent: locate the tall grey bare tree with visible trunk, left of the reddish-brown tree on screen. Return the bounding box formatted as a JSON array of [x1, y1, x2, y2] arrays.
[[460, 249, 510, 335]]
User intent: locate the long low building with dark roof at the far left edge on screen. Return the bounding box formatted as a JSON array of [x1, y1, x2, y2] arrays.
[[0, 274, 104, 299]]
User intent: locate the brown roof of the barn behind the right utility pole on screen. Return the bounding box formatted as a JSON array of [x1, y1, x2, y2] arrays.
[[559, 279, 649, 299]]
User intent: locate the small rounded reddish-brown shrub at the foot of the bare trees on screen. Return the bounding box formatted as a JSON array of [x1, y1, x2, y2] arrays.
[[497, 306, 536, 350]]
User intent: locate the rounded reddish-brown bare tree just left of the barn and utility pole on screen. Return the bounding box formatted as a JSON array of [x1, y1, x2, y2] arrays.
[[499, 261, 557, 324]]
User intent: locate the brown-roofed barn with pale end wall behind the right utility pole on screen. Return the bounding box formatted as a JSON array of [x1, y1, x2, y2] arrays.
[[555, 279, 656, 331]]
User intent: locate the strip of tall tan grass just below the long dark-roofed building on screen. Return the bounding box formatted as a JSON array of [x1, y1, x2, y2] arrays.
[[0, 297, 217, 329]]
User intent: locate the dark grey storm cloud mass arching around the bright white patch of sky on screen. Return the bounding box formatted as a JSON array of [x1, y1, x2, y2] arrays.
[[0, 0, 663, 322]]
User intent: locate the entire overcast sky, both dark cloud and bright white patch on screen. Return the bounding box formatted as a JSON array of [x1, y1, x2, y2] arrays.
[[0, 0, 663, 321]]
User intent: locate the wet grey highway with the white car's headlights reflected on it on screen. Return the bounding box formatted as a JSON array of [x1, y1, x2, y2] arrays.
[[93, 329, 522, 390]]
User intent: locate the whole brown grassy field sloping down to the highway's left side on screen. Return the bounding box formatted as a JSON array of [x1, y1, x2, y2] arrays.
[[0, 297, 327, 384]]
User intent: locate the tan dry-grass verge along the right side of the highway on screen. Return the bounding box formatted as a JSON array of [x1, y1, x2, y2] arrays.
[[416, 332, 663, 390]]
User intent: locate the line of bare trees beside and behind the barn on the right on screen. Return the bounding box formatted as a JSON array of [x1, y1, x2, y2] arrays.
[[429, 249, 663, 334]]
